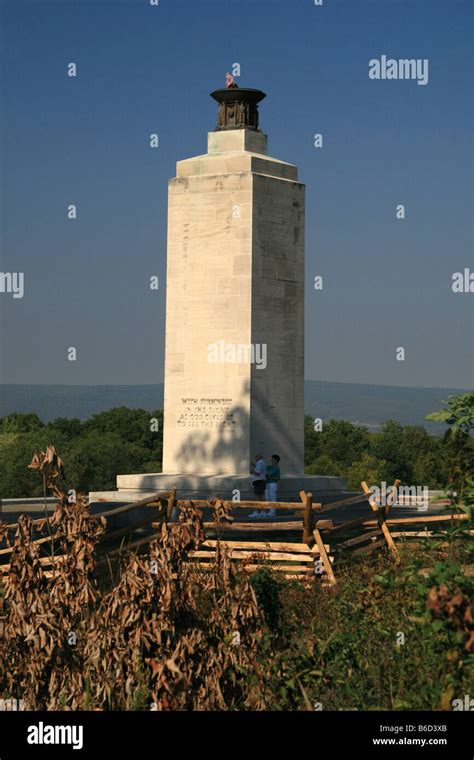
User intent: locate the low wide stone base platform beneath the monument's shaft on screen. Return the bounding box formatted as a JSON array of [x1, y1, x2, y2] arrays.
[[89, 473, 347, 503]]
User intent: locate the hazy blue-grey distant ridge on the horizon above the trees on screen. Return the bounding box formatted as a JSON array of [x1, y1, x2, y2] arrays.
[[0, 380, 466, 433]]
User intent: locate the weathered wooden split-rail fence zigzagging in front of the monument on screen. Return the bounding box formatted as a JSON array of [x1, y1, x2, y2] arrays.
[[0, 480, 473, 586]]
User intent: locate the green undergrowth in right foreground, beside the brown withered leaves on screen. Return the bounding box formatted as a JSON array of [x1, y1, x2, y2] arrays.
[[244, 540, 474, 710]]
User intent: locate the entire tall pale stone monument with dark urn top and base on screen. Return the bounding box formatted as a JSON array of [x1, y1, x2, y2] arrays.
[[91, 83, 345, 500]]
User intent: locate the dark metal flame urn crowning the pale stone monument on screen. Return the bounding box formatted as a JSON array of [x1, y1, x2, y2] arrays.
[[211, 85, 266, 132]]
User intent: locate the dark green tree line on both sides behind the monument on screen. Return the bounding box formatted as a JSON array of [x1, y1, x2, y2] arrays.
[[0, 393, 474, 498]]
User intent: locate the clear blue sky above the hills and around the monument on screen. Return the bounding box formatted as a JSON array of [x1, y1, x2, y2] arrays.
[[0, 0, 474, 387]]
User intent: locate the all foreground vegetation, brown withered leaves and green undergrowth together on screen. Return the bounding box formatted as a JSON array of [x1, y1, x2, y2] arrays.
[[0, 506, 474, 711]]
